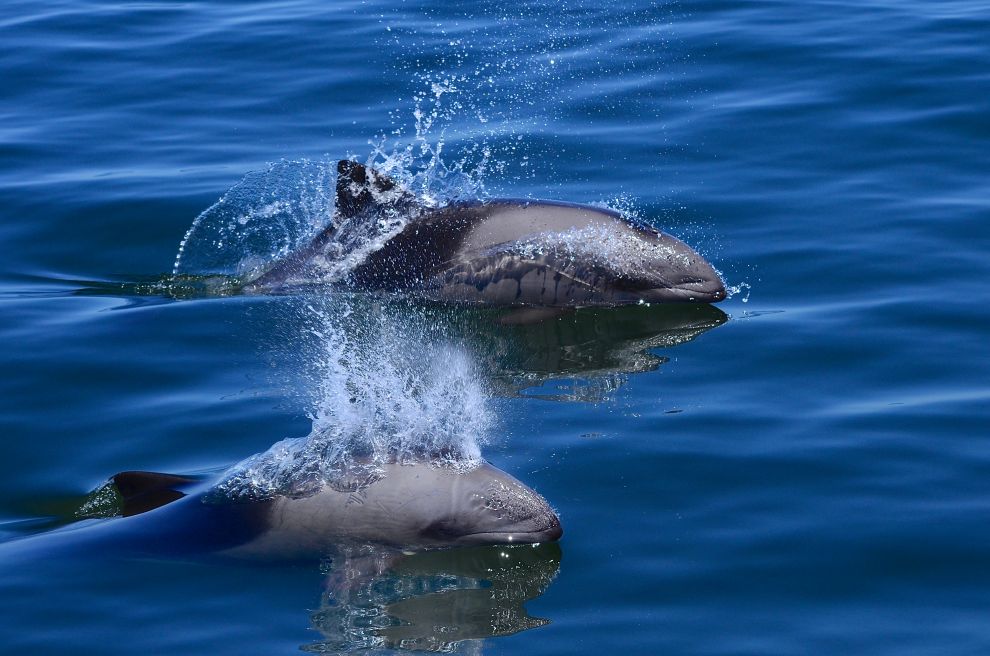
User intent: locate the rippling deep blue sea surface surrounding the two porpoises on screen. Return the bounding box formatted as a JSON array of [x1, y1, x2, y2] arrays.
[[0, 0, 990, 655]]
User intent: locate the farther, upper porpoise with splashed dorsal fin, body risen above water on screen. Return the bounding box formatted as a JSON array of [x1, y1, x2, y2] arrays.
[[243, 160, 726, 308]]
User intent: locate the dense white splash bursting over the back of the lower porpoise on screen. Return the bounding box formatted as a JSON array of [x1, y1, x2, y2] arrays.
[[218, 297, 493, 499]]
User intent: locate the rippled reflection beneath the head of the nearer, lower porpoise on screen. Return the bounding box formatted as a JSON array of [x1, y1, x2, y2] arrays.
[[307, 543, 560, 653]]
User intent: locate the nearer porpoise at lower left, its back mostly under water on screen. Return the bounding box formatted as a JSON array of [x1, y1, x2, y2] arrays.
[[3, 461, 562, 560]]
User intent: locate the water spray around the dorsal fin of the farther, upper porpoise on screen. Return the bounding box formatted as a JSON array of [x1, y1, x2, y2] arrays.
[[172, 88, 491, 295]]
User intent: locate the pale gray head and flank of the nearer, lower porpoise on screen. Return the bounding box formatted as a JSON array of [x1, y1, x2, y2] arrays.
[[227, 462, 562, 557]]
